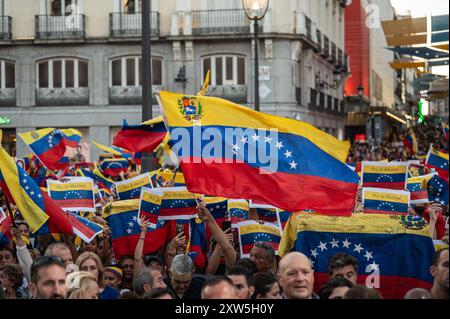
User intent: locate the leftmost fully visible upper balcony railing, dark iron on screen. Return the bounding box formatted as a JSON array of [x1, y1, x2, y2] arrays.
[[36, 14, 86, 40]]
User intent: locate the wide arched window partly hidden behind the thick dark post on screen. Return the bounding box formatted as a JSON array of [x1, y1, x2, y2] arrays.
[[110, 56, 163, 87]]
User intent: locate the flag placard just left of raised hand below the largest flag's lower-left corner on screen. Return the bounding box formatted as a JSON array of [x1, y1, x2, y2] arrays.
[[159, 187, 197, 220]]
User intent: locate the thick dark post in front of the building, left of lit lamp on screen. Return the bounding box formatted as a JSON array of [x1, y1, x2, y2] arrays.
[[141, 0, 155, 173]]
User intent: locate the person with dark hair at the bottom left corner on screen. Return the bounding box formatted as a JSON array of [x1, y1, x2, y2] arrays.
[[0, 264, 28, 299]]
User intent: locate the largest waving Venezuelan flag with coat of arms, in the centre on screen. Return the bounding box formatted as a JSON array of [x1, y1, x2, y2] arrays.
[[158, 92, 358, 215]]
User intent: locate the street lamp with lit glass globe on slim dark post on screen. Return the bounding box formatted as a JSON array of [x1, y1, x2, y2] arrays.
[[242, 0, 269, 112]]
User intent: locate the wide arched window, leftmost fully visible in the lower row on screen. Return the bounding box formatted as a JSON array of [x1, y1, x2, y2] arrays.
[[37, 58, 88, 89]]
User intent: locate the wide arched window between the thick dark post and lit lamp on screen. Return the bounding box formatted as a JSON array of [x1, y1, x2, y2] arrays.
[[202, 55, 245, 86]]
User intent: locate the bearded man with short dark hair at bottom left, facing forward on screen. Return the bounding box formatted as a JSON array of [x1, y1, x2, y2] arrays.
[[29, 256, 67, 299]]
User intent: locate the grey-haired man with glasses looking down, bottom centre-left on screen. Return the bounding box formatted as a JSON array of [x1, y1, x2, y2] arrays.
[[166, 255, 203, 299]]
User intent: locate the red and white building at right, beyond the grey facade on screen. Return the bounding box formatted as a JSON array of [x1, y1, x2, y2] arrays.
[[345, 0, 415, 143]]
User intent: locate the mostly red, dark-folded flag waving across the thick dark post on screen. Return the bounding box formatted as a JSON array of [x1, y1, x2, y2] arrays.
[[113, 116, 167, 152]]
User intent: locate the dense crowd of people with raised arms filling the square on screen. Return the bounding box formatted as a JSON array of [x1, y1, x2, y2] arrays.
[[0, 119, 449, 299]]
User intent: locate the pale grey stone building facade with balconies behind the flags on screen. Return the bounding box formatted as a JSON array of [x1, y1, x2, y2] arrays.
[[0, 0, 349, 160]]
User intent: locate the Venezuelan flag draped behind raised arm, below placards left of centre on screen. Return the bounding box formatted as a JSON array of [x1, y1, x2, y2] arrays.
[[103, 199, 167, 259]]
